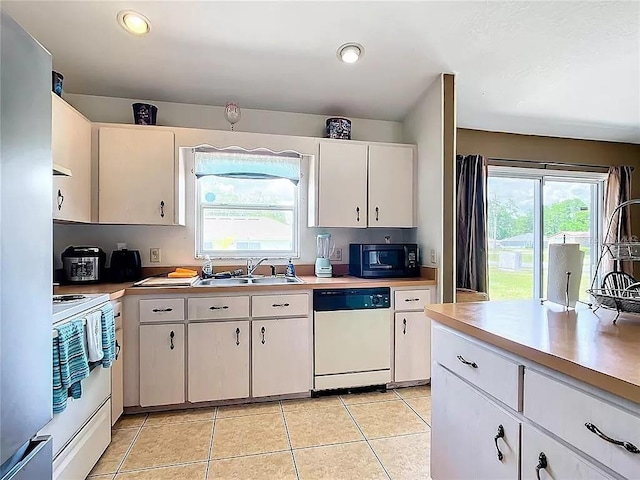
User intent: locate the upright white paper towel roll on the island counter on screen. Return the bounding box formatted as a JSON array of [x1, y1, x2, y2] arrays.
[[547, 243, 584, 307]]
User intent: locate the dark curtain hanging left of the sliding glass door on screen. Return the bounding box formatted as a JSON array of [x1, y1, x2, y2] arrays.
[[456, 155, 488, 292]]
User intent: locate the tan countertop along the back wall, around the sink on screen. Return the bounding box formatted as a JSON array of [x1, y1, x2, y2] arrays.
[[53, 275, 436, 300]]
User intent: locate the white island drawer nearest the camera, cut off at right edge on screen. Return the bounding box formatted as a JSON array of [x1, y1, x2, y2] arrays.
[[524, 369, 640, 478]]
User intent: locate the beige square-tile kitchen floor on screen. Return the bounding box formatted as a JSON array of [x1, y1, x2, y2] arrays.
[[89, 386, 431, 480]]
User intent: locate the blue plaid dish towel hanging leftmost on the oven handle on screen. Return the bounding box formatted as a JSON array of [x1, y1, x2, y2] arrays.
[[53, 318, 89, 414]]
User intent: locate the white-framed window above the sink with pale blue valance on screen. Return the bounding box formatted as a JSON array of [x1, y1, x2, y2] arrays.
[[194, 147, 300, 258]]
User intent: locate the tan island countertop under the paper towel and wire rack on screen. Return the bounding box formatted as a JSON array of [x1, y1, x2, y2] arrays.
[[425, 300, 640, 403]]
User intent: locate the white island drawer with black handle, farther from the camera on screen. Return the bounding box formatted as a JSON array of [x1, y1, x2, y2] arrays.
[[432, 326, 523, 411]]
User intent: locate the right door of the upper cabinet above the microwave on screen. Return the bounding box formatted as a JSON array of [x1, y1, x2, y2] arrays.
[[368, 145, 415, 227]]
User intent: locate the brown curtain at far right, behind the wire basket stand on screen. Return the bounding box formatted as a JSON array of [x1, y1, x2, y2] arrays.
[[603, 166, 633, 275]]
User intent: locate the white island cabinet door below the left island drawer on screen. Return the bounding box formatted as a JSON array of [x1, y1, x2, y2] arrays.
[[431, 364, 520, 480]]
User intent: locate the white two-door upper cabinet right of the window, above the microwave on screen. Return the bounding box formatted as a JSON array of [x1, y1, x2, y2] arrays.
[[309, 140, 415, 228]]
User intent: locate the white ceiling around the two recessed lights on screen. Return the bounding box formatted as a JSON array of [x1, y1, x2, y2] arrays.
[[2, 0, 640, 143]]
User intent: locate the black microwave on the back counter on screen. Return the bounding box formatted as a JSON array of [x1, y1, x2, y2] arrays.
[[349, 243, 420, 278]]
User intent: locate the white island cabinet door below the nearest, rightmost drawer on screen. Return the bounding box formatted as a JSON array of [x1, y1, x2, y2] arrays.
[[521, 424, 611, 480]]
